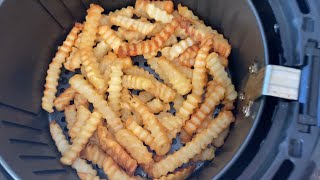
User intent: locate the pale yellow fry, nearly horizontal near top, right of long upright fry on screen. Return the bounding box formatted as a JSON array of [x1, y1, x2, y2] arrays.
[[110, 15, 155, 35]]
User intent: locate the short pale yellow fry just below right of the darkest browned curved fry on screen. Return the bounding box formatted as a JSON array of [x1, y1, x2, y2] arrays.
[[161, 37, 195, 61]]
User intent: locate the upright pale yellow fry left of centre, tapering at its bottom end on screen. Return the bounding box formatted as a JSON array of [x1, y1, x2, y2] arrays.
[[108, 65, 123, 115]]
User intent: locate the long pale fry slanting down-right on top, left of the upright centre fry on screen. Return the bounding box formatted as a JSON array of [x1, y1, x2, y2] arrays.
[[69, 75, 123, 132]]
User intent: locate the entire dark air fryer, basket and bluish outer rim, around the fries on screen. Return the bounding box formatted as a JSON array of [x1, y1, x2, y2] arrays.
[[0, 0, 320, 179]]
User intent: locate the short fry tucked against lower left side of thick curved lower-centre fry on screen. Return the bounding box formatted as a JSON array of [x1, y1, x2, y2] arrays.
[[126, 118, 154, 150]]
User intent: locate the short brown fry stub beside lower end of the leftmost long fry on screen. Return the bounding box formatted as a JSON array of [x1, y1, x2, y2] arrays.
[[54, 87, 76, 111]]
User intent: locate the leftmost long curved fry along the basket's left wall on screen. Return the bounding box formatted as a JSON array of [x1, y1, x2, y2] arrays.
[[41, 24, 80, 113]]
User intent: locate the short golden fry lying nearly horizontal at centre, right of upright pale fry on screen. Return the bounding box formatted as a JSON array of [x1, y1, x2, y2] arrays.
[[122, 75, 153, 90]]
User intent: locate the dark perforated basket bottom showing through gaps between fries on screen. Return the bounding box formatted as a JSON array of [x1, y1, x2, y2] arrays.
[[49, 56, 224, 178]]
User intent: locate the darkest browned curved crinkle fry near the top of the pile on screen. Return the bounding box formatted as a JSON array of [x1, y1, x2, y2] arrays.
[[118, 18, 179, 57]]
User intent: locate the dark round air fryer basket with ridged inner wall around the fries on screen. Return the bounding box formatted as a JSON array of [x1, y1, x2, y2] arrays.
[[0, 0, 269, 179]]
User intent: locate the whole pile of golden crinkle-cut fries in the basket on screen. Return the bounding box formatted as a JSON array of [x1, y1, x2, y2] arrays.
[[42, 0, 237, 179]]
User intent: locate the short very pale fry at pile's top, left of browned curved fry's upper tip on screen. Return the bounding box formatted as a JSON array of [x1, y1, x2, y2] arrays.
[[146, 3, 173, 23]]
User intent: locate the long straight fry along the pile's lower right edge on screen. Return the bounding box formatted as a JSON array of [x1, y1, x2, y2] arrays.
[[152, 111, 234, 178]]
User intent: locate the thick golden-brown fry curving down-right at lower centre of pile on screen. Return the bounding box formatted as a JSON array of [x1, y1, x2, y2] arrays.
[[130, 97, 170, 155]]
